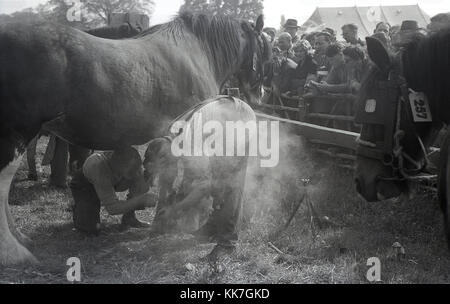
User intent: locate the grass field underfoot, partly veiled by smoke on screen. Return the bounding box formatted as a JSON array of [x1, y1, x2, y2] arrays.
[[0, 134, 450, 283]]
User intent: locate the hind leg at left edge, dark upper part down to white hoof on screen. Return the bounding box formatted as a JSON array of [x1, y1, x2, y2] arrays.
[[0, 138, 37, 265]]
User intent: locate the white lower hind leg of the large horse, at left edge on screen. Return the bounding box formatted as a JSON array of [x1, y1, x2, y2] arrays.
[[0, 154, 37, 265]]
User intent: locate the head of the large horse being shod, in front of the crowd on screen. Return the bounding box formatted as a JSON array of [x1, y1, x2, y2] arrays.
[[236, 15, 272, 104]]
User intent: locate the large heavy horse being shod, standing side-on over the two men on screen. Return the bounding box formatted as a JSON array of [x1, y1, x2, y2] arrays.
[[0, 12, 270, 265]]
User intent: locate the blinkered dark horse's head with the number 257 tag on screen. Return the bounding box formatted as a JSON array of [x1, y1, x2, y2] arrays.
[[355, 37, 442, 201]]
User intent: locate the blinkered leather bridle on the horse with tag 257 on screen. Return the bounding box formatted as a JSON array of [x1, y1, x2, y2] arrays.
[[355, 60, 432, 181]]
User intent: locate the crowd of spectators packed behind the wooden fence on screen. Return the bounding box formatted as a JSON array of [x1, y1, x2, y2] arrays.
[[264, 13, 450, 102]]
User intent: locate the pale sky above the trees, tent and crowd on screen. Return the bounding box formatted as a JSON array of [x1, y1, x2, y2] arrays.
[[0, 0, 450, 28]]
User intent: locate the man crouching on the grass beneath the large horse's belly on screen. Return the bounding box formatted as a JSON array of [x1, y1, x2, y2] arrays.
[[70, 147, 156, 235]]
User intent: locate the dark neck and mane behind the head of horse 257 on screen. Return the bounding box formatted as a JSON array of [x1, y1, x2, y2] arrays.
[[402, 29, 450, 123]]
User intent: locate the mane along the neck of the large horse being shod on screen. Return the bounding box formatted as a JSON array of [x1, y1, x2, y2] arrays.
[[135, 12, 258, 75]]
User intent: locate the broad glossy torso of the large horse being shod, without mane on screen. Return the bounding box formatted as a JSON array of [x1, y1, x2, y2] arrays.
[[0, 17, 219, 149]]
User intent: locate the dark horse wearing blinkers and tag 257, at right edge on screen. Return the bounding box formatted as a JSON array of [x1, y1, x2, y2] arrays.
[[355, 30, 450, 245]]
